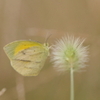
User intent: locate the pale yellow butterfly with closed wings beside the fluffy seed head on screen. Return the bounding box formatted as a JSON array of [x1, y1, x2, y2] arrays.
[[4, 40, 50, 76]]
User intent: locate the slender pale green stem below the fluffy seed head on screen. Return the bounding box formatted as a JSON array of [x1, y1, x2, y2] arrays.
[[70, 67, 74, 100]]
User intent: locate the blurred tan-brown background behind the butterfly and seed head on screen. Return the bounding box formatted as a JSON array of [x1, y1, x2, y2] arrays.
[[0, 0, 100, 100]]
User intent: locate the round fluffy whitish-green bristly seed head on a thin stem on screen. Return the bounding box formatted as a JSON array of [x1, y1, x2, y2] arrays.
[[51, 36, 88, 71]]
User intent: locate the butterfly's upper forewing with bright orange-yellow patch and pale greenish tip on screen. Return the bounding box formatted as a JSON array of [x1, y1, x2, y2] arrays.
[[4, 40, 42, 59]]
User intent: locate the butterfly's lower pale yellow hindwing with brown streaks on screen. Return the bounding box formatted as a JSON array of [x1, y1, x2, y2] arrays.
[[3, 40, 48, 76]]
